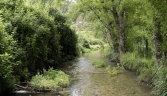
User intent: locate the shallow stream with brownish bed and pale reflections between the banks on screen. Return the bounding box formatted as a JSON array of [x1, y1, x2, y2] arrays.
[[11, 51, 153, 96]]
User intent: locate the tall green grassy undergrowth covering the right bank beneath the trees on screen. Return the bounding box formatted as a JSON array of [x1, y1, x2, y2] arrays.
[[121, 53, 167, 96]]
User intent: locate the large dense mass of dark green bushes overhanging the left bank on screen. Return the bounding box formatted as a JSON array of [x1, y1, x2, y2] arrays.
[[1, 1, 77, 72]]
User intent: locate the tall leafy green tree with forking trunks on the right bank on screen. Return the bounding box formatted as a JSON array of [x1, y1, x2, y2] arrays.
[[69, 0, 151, 62]]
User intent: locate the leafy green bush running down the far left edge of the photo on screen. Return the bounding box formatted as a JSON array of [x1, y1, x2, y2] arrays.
[[0, 17, 21, 93]]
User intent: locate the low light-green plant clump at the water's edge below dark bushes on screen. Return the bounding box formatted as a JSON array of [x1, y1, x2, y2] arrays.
[[31, 68, 70, 90]]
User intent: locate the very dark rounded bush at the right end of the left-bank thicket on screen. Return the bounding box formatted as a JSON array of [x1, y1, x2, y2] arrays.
[[58, 25, 78, 58]]
